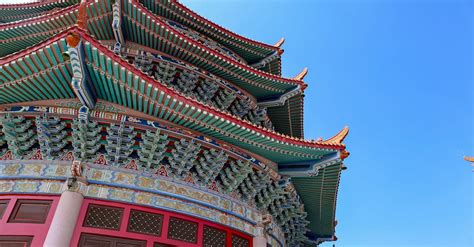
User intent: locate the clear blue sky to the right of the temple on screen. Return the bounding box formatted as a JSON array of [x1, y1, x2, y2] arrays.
[[182, 0, 474, 247]]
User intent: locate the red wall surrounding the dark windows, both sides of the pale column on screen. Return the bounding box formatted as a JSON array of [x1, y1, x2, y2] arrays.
[[0, 195, 252, 247]]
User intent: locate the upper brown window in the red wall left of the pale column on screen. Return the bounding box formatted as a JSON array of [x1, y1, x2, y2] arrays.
[[8, 200, 53, 224]]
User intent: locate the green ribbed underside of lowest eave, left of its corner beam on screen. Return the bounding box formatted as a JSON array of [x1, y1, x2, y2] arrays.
[[0, 36, 75, 104]]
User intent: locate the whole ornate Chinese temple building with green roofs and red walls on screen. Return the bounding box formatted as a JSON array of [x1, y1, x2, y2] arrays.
[[0, 0, 349, 247]]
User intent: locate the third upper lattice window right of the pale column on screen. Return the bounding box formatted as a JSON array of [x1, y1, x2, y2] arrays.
[[168, 217, 198, 243]]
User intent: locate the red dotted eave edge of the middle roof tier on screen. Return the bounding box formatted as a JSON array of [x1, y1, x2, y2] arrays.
[[130, 0, 307, 97]]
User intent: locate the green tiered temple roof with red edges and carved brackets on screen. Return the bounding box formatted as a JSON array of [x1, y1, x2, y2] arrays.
[[0, 0, 348, 246]]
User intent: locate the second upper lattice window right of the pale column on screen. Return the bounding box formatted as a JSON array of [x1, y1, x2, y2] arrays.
[[127, 210, 163, 236]]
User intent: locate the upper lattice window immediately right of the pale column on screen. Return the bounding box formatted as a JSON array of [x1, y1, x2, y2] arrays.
[[84, 204, 123, 230]]
